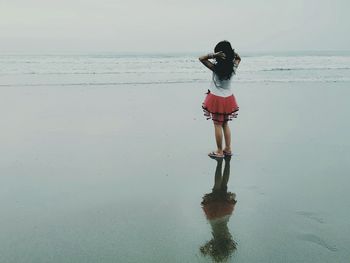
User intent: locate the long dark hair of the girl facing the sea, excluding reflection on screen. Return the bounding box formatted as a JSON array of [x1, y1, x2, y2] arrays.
[[214, 40, 236, 80]]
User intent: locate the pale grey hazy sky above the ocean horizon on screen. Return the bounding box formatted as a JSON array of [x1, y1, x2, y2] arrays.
[[0, 0, 350, 53]]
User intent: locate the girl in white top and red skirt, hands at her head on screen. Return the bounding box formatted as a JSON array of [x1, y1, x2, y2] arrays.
[[199, 41, 241, 159]]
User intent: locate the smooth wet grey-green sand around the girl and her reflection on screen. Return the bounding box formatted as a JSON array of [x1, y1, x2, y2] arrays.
[[0, 82, 350, 263]]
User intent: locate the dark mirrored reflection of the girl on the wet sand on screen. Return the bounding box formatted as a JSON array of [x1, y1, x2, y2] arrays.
[[200, 157, 237, 262]]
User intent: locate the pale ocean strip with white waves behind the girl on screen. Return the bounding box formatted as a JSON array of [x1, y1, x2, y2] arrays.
[[0, 52, 350, 87]]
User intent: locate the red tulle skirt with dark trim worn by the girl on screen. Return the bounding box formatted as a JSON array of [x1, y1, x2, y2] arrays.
[[202, 91, 239, 124]]
